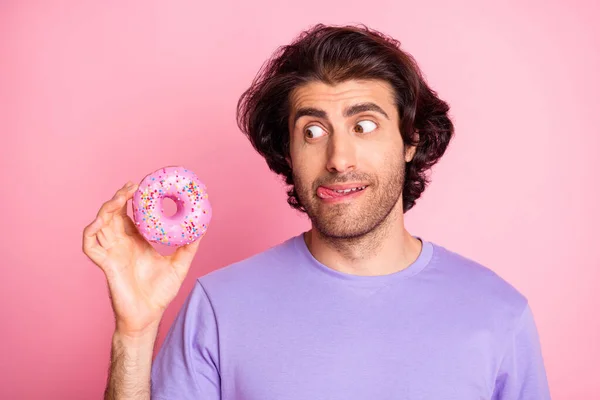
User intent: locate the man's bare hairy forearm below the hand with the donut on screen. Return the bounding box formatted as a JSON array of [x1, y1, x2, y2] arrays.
[[104, 328, 158, 400]]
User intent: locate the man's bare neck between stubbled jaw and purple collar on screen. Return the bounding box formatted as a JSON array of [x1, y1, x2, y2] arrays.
[[304, 202, 422, 276]]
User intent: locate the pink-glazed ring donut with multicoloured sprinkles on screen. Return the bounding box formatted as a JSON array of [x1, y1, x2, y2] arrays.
[[132, 166, 212, 247]]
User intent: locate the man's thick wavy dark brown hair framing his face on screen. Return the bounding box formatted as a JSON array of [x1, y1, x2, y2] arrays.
[[237, 24, 454, 213]]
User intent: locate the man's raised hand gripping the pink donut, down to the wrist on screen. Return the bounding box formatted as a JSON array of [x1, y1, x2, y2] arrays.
[[83, 182, 200, 336]]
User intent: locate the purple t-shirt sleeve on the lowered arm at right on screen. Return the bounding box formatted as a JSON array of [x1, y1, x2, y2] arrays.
[[492, 305, 550, 400]]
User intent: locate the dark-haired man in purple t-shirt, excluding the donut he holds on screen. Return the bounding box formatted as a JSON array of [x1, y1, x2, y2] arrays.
[[84, 25, 550, 400]]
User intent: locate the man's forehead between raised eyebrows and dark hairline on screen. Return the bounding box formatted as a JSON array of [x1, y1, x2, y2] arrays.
[[290, 80, 396, 112]]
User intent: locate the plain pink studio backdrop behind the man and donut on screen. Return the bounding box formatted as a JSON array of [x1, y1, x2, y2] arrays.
[[0, 0, 600, 399]]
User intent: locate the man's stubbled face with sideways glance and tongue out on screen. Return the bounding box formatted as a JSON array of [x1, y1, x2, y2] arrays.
[[288, 80, 414, 238]]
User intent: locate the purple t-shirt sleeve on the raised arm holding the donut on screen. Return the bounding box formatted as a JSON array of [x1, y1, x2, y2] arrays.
[[151, 281, 221, 400]]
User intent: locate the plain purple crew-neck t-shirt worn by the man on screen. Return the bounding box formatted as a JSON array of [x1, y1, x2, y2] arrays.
[[152, 235, 550, 400]]
